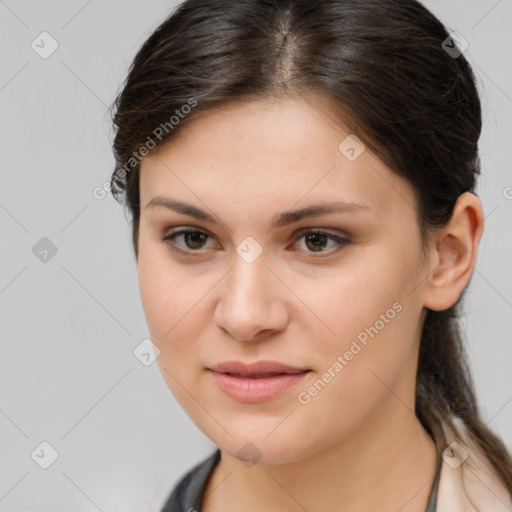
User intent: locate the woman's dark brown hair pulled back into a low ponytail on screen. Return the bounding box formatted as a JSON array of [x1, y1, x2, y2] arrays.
[[111, 0, 512, 494]]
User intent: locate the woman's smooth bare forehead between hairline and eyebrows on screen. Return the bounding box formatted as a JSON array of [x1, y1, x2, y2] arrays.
[[140, 95, 414, 221]]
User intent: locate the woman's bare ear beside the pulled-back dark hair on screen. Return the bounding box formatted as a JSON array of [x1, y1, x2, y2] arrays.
[[424, 192, 484, 311]]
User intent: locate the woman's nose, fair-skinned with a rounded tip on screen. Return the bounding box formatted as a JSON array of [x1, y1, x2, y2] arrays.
[[214, 254, 290, 341]]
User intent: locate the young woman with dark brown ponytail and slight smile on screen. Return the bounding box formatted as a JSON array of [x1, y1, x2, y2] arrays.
[[111, 0, 512, 512]]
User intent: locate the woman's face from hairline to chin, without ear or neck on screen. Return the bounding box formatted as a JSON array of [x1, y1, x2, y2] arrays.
[[138, 95, 427, 463]]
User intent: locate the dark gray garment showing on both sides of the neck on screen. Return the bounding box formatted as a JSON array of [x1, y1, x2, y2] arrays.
[[161, 427, 445, 512]]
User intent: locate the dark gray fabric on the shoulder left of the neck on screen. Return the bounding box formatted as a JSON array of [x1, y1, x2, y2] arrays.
[[161, 449, 220, 512]]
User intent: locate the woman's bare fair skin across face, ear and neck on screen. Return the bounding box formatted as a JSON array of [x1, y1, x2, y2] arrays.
[[138, 94, 483, 512]]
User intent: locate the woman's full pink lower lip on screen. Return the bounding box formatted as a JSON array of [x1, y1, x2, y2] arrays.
[[210, 370, 309, 403]]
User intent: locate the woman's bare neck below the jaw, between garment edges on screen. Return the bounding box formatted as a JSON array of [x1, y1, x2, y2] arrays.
[[202, 393, 437, 512]]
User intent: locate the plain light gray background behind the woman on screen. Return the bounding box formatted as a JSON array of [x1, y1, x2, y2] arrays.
[[0, 0, 512, 512]]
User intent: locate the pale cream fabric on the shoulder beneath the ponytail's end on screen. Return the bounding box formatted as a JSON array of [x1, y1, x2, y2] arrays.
[[437, 418, 512, 512]]
